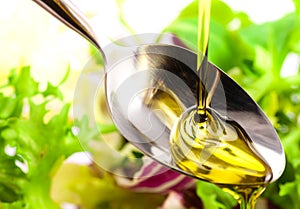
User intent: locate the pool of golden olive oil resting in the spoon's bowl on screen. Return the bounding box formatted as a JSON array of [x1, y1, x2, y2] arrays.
[[171, 108, 272, 185]]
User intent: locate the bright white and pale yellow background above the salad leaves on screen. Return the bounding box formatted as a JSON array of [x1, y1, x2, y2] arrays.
[[0, 0, 294, 89]]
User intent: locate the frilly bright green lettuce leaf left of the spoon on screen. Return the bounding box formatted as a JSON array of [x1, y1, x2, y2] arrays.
[[0, 67, 81, 209]]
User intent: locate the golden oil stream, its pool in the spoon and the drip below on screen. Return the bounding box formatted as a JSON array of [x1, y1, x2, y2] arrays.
[[170, 0, 272, 209]]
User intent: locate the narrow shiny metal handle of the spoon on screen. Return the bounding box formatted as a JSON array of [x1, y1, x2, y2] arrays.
[[33, 0, 104, 56]]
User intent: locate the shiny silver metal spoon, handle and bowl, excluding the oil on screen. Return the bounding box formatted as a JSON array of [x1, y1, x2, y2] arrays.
[[33, 0, 285, 181]]
